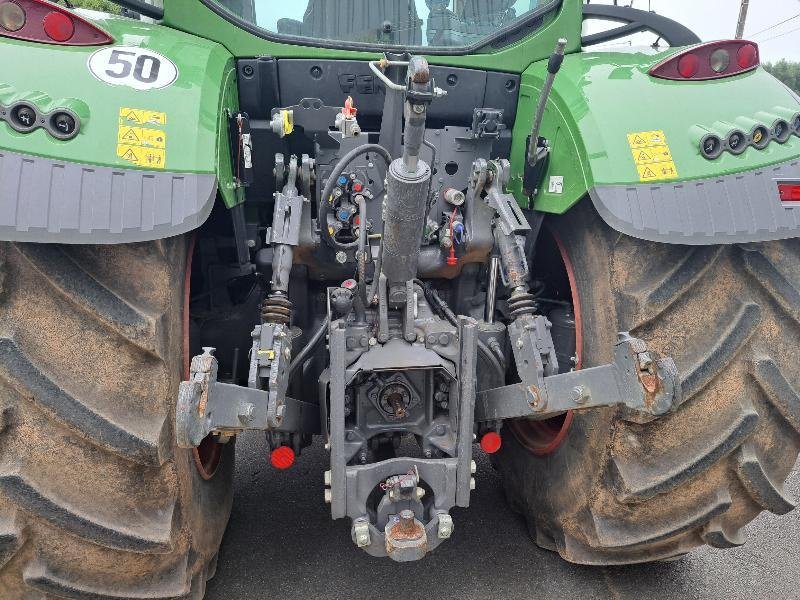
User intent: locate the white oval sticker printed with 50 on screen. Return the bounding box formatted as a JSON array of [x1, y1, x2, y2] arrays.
[[88, 46, 178, 90]]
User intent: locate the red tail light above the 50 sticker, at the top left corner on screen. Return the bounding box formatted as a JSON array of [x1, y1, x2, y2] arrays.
[[0, 0, 114, 46]]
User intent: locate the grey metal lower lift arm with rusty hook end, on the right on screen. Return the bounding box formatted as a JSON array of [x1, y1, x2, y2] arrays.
[[475, 333, 682, 422]]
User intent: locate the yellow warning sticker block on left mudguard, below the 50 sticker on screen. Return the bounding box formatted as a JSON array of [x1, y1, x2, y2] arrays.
[[117, 108, 167, 169]]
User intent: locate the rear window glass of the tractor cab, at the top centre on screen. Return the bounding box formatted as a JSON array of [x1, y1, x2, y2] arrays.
[[207, 0, 560, 49]]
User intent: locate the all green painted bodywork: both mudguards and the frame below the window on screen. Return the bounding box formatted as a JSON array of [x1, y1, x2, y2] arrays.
[[0, 0, 800, 213]]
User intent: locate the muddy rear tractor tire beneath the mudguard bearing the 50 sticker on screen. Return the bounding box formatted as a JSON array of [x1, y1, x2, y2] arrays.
[[0, 237, 234, 600]]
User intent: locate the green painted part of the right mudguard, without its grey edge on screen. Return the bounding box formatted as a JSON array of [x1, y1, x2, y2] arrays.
[[511, 49, 800, 213]]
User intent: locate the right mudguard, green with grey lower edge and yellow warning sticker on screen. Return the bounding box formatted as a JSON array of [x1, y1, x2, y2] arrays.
[[512, 48, 800, 245]]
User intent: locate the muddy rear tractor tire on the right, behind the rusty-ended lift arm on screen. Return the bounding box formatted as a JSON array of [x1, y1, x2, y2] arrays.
[[497, 201, 800, 565]]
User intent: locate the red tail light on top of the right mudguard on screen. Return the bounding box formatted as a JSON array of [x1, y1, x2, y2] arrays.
[[650, 40, 761, 81]]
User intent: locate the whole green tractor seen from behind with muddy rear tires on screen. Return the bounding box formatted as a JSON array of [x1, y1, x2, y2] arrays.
[[0, 0, 800, 599]]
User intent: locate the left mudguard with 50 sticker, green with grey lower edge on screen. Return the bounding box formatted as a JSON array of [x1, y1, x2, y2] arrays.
[[0, 12, 238, 243]]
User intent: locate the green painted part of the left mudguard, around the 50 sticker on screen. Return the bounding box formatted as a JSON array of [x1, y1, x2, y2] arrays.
[[0, 17, 238, 206]]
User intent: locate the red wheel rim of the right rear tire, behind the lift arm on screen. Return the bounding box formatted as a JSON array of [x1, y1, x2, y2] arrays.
[[509, 228, 583, 456]]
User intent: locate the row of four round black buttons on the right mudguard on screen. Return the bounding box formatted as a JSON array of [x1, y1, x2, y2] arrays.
[[700, 109, 800, 160]]
